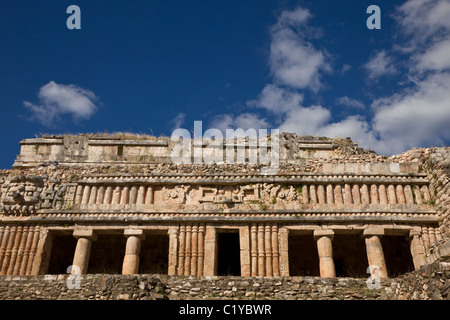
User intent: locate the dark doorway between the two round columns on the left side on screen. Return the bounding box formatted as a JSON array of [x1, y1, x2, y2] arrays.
[[87, 234, 126, 274]]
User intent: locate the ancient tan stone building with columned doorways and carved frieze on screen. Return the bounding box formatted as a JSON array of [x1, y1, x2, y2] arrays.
[[0, 134, 450, 278]]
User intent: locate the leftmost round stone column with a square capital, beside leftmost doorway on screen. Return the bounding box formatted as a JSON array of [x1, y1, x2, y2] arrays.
[[72, 229, 97, 274]]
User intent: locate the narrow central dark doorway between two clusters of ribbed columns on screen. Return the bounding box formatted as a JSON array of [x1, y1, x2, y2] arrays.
[[217, 231, 241, 276]]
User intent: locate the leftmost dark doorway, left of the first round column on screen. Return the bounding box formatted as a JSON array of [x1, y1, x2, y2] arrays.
[[47, 234, 77, 274]]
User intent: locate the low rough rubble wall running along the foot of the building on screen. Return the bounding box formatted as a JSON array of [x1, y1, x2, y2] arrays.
[[0, 262, 450, 300]]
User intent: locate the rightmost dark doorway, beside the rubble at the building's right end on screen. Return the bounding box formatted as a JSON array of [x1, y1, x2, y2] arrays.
[[381, 235, 414, 278]]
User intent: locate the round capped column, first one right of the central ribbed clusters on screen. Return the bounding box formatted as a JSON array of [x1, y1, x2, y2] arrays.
[[314, 230, 336, 278]]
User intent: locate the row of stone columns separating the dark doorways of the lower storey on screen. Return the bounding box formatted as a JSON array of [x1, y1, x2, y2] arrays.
[[67, 223, 436, 278]]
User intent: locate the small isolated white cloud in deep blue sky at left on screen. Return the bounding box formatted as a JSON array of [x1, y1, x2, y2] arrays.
[[24, 81, 97, 125]]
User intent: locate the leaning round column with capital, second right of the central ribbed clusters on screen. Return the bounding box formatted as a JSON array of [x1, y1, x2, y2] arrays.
[[363, 228, 388, 278]]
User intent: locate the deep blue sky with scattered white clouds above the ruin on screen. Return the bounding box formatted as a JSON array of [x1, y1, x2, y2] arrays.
[[0, 0, 450, 168]]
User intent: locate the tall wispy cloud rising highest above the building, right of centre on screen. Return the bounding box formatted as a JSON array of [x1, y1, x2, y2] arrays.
[[269, 8, 330, 92]]
